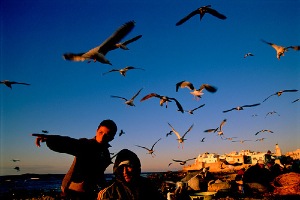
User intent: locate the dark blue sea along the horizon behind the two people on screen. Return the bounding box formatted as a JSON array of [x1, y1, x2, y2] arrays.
[[0, 172, 160, 199]]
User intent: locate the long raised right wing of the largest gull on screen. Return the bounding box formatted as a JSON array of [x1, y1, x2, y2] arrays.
[[95, 21, 135, 55]]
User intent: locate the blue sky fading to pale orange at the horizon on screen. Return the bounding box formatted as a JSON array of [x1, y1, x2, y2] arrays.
[[0, 0, 300, 175]]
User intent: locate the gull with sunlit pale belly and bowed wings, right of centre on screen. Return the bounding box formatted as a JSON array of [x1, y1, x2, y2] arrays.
[[176, 81, 217, 100]]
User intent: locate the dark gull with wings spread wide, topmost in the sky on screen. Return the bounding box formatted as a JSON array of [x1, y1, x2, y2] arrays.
[[176, 5, 227, 26]]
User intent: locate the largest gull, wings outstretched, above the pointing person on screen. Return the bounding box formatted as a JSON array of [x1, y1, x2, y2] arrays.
[[63, 21, 135, 65]]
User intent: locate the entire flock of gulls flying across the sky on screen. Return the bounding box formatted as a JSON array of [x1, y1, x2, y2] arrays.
[[0, 5, 300, 170]]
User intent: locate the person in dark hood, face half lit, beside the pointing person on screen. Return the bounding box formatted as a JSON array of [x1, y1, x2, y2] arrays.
[[98, 149, 164, 200]]
